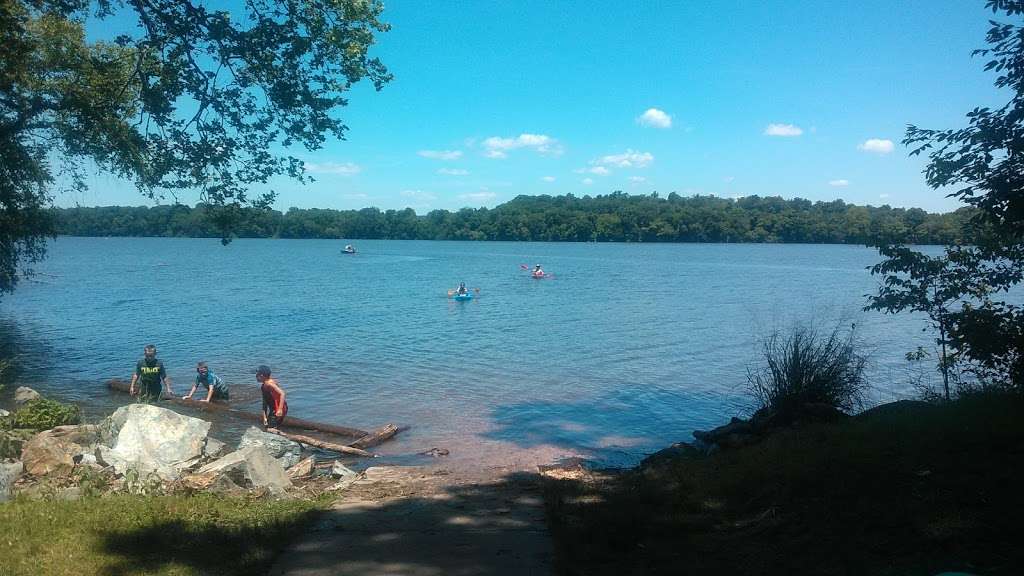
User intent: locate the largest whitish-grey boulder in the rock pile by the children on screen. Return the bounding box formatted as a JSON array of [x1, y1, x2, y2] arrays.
[[96, 404, 210, 481]]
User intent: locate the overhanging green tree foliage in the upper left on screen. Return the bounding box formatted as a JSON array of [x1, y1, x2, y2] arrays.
[[0, 0, 391, 293]]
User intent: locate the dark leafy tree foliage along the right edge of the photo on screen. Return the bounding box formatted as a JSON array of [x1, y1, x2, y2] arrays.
[[869, 0, 1024, 389]]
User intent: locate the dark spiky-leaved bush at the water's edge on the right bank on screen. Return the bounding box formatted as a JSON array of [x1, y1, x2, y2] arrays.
[[746, 327, 867, 414]]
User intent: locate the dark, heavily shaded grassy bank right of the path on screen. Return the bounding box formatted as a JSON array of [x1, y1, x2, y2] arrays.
[[546, 397, 1024, 576]]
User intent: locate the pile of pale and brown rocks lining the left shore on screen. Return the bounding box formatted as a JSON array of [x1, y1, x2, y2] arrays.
[[0, 386, 385, 502]]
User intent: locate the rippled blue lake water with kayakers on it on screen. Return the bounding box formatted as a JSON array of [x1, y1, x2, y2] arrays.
[[0, 238, 929, 466]]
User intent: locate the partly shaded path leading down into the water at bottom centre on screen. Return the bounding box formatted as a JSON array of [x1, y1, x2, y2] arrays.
[[270, 466, 552, 576]]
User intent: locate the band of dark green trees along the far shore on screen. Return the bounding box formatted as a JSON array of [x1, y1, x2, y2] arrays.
[[51, 192, 974, 245]]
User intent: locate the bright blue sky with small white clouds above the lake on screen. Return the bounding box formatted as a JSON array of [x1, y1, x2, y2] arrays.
[[70, 0, 1007, 213]]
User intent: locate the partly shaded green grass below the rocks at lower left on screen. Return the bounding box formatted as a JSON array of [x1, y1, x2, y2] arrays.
[[0, 487, 321, 576]]
